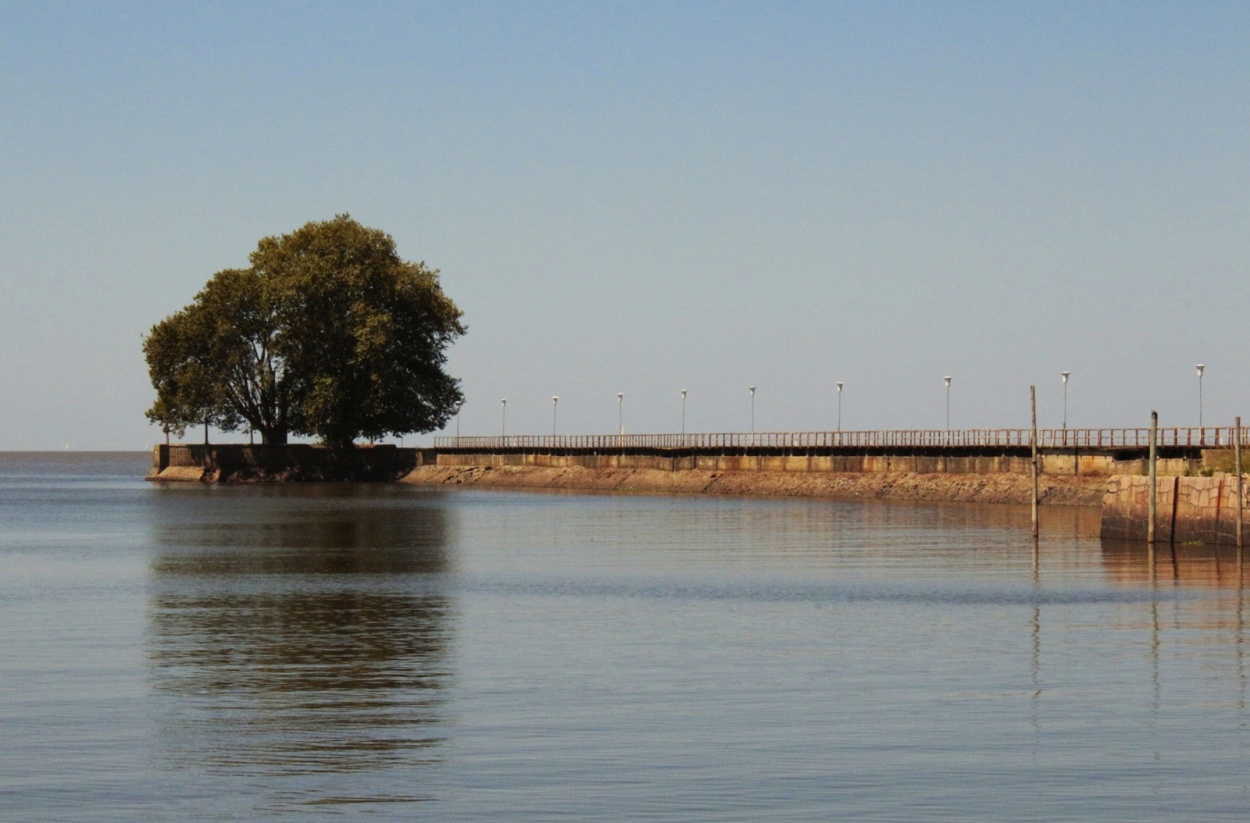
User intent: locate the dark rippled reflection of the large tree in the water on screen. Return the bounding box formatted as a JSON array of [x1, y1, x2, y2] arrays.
[[148, 485, 453, 803]]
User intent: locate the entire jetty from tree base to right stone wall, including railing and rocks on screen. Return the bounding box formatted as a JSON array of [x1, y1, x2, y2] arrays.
[[149, 427, 1248, 543]]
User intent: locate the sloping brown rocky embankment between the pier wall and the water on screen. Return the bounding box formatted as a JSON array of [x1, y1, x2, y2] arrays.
[[400, 465, 1108, 505]]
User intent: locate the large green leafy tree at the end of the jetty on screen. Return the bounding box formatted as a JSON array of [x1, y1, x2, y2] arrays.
[[144, 215, 465, 447]]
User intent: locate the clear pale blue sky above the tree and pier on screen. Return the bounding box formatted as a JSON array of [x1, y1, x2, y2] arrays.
[[0, 0, 1250, 450]]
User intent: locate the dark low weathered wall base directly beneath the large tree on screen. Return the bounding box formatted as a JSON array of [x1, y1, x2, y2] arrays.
[[148, 444, 434, 483]]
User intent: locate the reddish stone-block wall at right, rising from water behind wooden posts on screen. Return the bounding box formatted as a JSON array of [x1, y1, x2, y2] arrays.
[[1101, 475, 1250, 544]]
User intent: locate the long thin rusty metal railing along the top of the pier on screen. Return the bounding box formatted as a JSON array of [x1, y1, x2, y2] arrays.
[[434, 427, 1250, 452]]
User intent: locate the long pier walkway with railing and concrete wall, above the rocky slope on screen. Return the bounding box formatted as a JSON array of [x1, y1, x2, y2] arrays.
[[434, 427, 1246, 477]]
